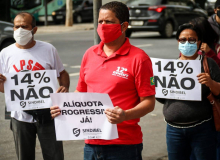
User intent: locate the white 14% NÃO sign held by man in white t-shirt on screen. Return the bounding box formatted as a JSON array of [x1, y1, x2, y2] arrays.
[[4, 70, 58, 111]]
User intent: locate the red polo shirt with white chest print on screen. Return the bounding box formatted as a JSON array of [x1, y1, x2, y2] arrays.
[[77, 39, 155, 145]]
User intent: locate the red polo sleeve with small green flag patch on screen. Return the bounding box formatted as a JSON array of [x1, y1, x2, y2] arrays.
[[135, 57, 155, 97]]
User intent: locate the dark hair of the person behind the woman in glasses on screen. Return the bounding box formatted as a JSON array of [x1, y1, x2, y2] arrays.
[[189, 17, 219, 47]]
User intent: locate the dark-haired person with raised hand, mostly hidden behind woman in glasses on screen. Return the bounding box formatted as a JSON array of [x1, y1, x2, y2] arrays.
[[189, 17, 220, 67]]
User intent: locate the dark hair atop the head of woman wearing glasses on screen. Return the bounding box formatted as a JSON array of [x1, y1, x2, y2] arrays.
[[176, 23, 202, 41]]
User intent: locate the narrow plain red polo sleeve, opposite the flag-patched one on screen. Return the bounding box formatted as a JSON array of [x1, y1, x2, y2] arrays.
[[76, 55, 87, 92]]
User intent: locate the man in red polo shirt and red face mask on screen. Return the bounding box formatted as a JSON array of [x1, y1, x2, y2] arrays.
[[51, 2, 155, 160]]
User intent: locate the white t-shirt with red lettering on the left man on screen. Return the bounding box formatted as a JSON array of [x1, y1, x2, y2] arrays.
[[0, 41, 64, 123]]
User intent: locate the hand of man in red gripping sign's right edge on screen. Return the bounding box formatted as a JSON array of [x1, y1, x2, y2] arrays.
[[105, 106, 126, 124]]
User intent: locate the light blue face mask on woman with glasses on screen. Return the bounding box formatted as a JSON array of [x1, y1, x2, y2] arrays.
[[179, 41, 197, 57]]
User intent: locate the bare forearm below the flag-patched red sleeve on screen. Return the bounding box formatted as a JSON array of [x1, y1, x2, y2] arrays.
[[125, 96, 155, 120]]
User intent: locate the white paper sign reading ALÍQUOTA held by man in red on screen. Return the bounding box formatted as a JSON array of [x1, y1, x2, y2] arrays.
[[51, 93, 118, 141]]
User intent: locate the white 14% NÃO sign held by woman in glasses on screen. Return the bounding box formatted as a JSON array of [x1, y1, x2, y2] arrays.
[[151, 58, 201, 101]]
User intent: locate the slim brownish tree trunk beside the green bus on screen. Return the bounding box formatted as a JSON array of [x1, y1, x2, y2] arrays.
[[65, 0, 73, 27]]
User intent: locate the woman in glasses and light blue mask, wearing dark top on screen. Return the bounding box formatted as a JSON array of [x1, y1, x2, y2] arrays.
[[157, 23, 220, 160]]
